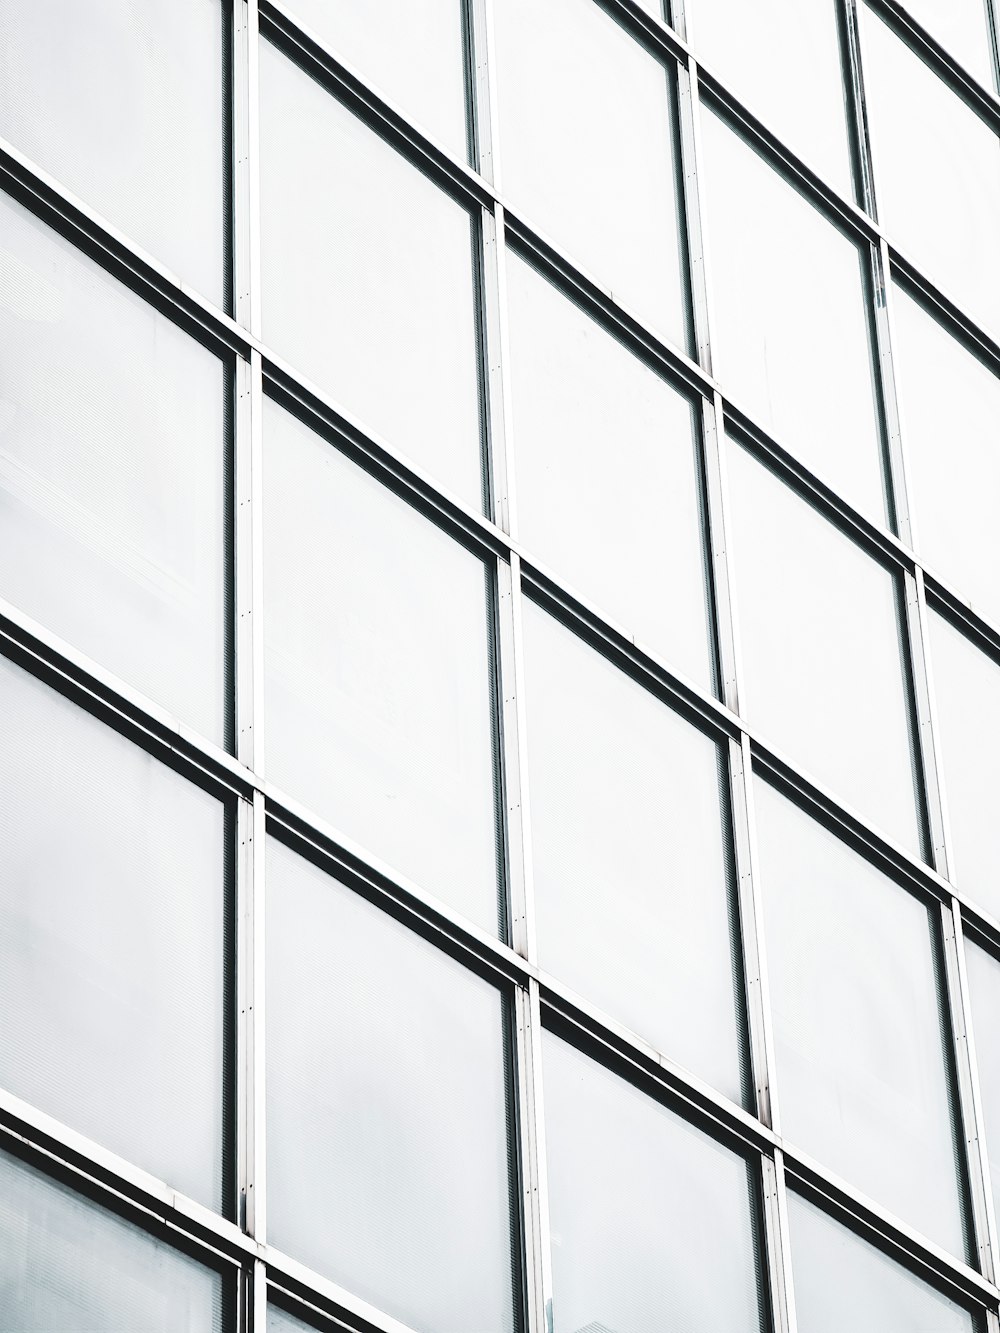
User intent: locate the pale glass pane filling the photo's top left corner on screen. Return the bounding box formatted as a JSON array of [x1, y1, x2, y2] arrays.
[[0, 0, 228, 305]]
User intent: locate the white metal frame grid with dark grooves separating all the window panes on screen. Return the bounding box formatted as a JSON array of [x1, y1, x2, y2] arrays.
[[0, 0, 1000, 1333]]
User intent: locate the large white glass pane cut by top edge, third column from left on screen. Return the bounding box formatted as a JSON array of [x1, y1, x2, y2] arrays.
[[496, 0, 688, 347]]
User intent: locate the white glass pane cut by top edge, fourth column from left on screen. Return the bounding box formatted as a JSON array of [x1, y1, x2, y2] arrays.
[[691, 0, 855, 199]]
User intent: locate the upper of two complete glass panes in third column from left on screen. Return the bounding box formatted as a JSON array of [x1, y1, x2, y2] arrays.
[[507, 255, 715, 689]]
